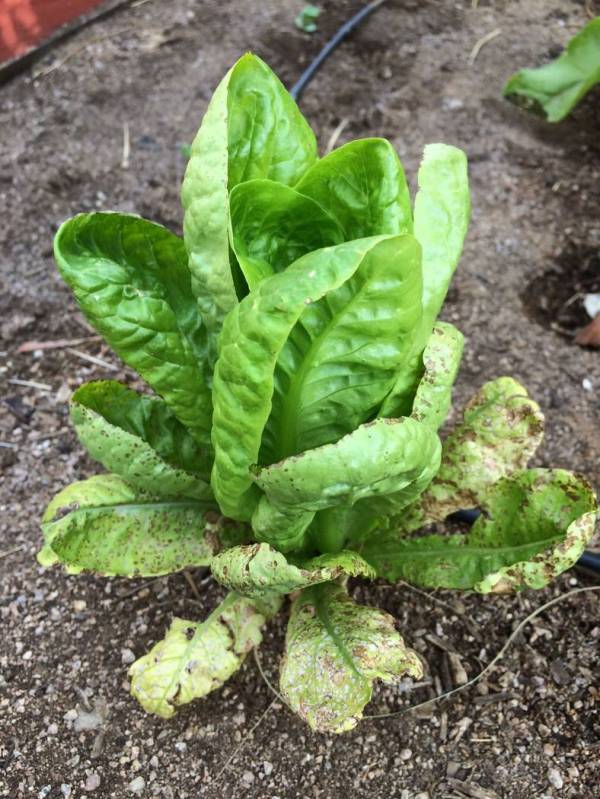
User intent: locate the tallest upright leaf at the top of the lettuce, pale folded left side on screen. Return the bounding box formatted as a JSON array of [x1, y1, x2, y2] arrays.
[[182, 53, 317, 363]]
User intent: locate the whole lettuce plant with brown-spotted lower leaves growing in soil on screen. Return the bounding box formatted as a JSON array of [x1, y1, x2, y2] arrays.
[[39, 55, 595, 732]]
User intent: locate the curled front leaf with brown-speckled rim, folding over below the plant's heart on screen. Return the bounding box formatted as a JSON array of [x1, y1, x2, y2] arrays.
[[252, 417, 441, 552]]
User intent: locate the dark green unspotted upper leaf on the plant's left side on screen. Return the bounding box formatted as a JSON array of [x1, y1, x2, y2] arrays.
[[54, 213, 211, 446]]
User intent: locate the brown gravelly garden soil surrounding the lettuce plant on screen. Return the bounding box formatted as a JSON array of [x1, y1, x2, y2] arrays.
[[0, 0, 600, 799]]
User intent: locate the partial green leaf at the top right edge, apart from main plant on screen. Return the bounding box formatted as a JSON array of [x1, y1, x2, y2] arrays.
[[504, 17, 600, 122]]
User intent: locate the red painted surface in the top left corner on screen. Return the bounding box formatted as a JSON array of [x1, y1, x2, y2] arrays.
[[0, 0, 102, 62]]
